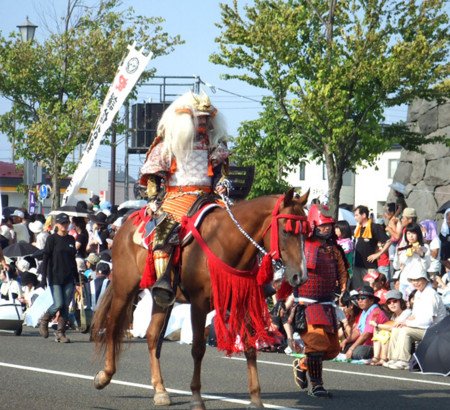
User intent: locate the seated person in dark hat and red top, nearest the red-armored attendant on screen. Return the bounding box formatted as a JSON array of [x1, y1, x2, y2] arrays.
[[344, 285, 389, 360]]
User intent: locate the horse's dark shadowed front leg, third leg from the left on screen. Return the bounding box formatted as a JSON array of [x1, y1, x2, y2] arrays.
[[190, 302, 209, 410]]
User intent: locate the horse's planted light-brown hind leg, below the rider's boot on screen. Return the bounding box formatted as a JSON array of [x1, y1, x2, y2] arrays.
[[147, 303, 171, 406]]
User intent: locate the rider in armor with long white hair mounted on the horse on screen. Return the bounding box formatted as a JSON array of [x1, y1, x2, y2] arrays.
[[140, 92, 229, 307]]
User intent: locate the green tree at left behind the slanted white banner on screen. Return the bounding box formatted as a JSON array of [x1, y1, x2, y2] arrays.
[[0, 0, 182, 209]]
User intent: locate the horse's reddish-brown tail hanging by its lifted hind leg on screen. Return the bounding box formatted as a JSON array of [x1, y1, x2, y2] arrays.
[[91, 283, 134, 359]]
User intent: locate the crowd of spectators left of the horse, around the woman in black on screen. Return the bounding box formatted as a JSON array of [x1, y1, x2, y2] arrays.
[[0, 195, 125, 342]]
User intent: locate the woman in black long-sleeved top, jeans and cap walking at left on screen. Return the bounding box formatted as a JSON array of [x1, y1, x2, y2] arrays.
[[39, 213, 78, 343]]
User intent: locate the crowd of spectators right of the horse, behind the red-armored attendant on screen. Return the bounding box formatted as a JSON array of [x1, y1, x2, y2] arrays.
[[272, 197, 450, 370]]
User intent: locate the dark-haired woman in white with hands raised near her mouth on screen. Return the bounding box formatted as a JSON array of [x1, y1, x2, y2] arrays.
[[394, 223, 430, 300]]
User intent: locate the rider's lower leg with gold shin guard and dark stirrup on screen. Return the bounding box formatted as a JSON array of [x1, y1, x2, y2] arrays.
[[152, 250, 175, 309]]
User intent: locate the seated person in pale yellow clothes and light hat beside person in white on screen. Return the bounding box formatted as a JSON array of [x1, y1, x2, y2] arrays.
[[370, 290, 411, 366]]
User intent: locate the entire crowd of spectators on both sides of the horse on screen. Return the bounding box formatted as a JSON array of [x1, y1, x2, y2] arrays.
[[0, 191, 450, 369]]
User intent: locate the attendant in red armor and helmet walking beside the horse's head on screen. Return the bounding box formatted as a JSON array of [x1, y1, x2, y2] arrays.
[[293, 204, 348, 397]]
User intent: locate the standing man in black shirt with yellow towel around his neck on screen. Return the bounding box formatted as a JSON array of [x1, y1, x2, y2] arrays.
[[352, 205, 391, 289]]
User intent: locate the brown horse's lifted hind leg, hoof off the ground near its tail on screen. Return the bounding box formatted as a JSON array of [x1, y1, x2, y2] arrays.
[[94, 293, 132, 390]]
